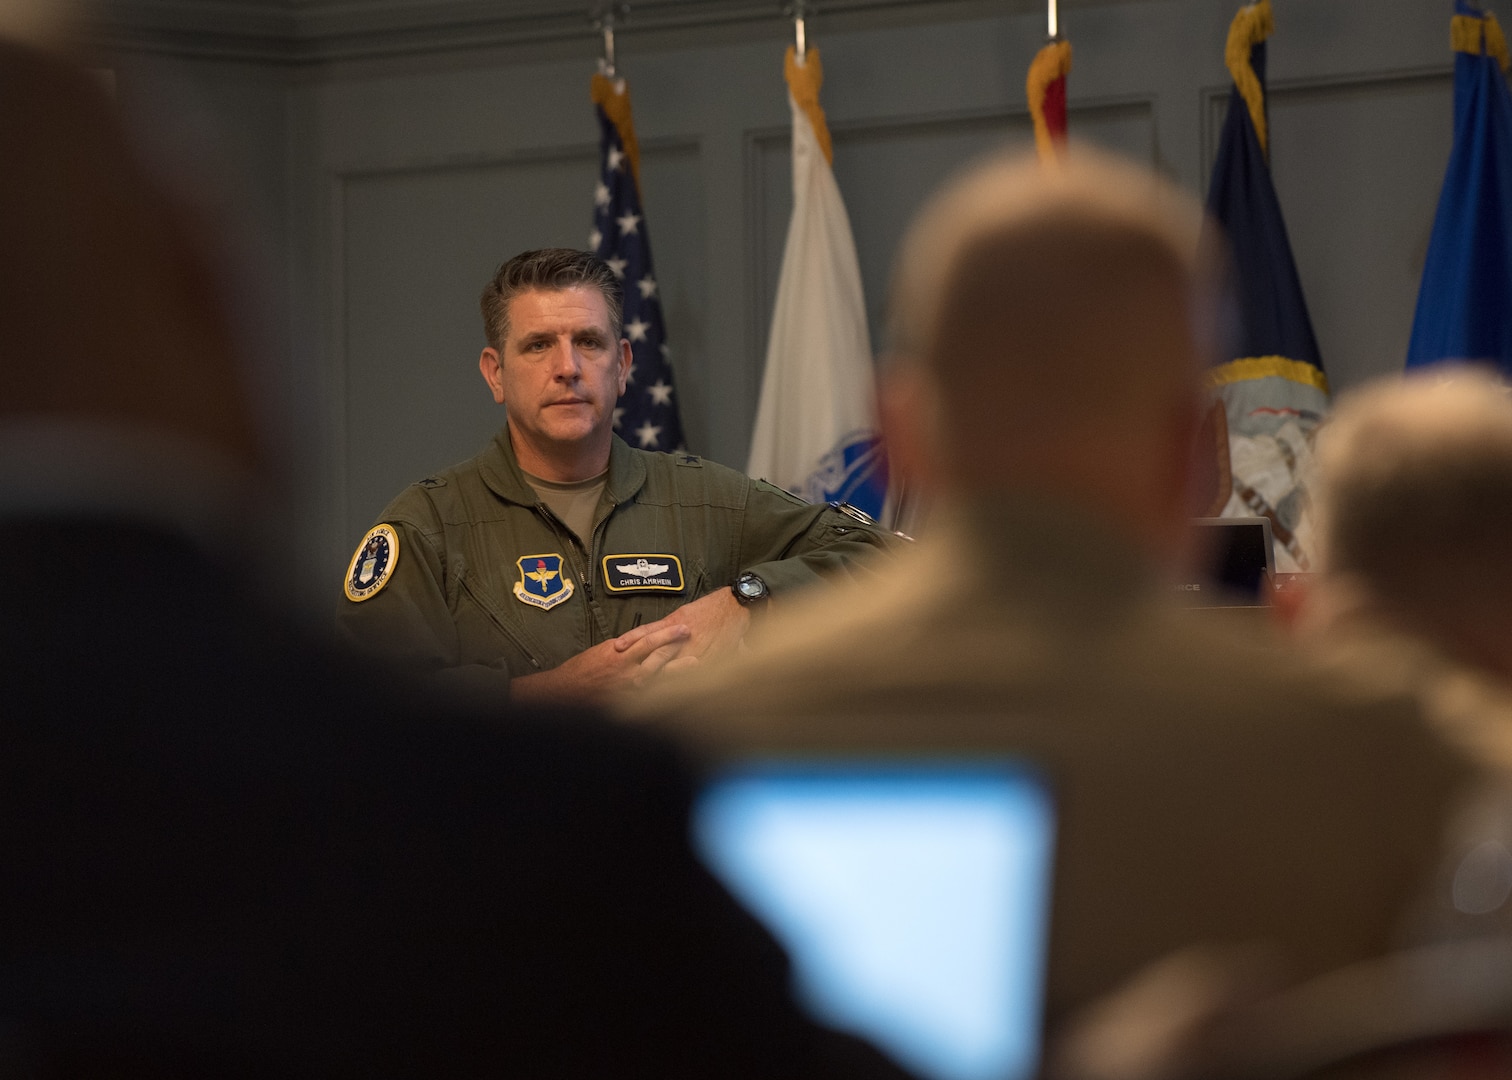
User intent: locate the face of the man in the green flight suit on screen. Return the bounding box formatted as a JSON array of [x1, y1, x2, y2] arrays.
[[478, 286, 631, 464]]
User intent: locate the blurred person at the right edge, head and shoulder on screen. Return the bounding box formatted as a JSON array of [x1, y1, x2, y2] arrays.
[[1296, 365, 1512, 939]]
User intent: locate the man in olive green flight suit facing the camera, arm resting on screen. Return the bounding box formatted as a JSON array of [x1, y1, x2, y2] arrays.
[[339, 248, 892, 700]]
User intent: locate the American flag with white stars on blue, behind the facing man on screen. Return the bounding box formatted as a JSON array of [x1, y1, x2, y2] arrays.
[[588, 74, 685, 451]]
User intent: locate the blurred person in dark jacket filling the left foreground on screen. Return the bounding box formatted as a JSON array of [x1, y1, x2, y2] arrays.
[[0, 33, 900, 1077]]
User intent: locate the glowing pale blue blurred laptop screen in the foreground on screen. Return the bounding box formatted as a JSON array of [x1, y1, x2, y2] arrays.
[[694, 758, 1054, 1080]]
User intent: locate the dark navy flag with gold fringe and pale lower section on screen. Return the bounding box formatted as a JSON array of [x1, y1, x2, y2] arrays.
[[1208, 0, 1328, 570]]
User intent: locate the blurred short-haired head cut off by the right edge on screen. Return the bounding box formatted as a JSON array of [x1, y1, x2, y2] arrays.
[[1314, 369, 1512, 679]]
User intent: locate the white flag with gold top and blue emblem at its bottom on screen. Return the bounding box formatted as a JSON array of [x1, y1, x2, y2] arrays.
[[747, 47, 888, 517]]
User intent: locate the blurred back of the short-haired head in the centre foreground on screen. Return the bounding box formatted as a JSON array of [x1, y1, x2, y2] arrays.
[[881, 147, 1216, 551]]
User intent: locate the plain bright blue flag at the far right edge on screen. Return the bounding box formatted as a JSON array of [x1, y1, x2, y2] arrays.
[[1408, 0, 1512, 375]]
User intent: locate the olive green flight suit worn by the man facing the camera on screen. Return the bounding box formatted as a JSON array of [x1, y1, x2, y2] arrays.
[[337, 430, 894, 690]]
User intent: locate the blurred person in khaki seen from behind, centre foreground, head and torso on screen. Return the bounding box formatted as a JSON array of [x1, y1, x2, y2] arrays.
[[622, 150, 1475, 1030]]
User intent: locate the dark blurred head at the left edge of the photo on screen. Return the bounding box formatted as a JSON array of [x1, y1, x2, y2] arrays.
[[0, 32, 263, 473]]
